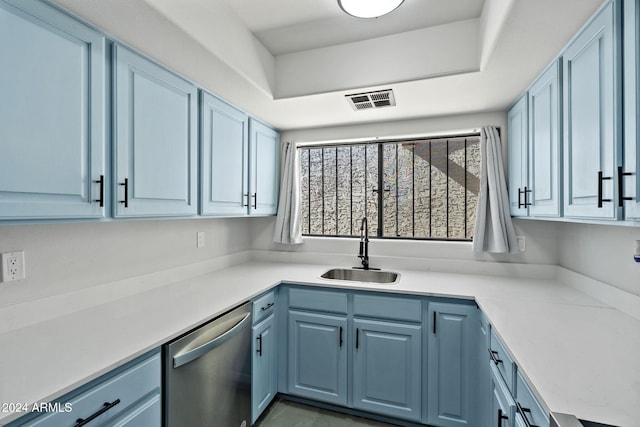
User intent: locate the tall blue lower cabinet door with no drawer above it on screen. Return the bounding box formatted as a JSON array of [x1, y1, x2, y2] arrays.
[[427, 303, 476, 427]]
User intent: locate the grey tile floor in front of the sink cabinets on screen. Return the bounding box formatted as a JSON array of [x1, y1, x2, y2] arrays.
[[254, 399, 394, 427]]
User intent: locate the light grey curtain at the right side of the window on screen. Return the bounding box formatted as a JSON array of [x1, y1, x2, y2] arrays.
[[473, 126, 519, 253]]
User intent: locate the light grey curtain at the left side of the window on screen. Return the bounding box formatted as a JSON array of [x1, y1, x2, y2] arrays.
[[273, 142, 302, 245]]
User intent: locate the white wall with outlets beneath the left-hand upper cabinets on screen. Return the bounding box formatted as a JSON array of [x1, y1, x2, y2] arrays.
[[0, 218, 251, 307]]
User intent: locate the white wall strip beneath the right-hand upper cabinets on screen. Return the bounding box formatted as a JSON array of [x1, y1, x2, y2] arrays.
[[558, 223, 640, 295]]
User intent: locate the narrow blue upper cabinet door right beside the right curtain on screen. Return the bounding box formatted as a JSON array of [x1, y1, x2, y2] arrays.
[[507, 95, 529, 216]]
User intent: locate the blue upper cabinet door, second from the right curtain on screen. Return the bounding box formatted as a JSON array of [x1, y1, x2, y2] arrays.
[[528, 61, 561, 217]]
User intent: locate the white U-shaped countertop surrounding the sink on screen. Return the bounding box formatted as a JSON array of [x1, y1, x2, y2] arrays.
[[0, 262, 640, 427]]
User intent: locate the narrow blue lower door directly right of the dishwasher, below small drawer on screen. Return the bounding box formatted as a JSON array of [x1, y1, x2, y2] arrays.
[[251, 314, 277, 424]]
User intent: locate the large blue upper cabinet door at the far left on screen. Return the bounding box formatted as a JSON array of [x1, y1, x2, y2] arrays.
[[0, 1, 106, 219]]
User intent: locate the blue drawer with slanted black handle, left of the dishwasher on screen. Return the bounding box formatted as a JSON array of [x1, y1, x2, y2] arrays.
[[17, 352, 162, 427]]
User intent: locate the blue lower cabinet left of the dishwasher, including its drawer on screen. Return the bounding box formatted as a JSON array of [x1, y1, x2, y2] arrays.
[[7, 350, 162, 427]]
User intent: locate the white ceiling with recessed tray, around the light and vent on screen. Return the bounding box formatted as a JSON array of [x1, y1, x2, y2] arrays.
[[55, 0, 604, 130]]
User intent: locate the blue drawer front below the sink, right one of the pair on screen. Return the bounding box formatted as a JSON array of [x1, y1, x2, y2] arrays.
[[353, 294, 422, 323]]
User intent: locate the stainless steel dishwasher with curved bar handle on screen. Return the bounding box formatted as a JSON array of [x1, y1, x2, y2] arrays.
[[164, 303, 251, 427]]
